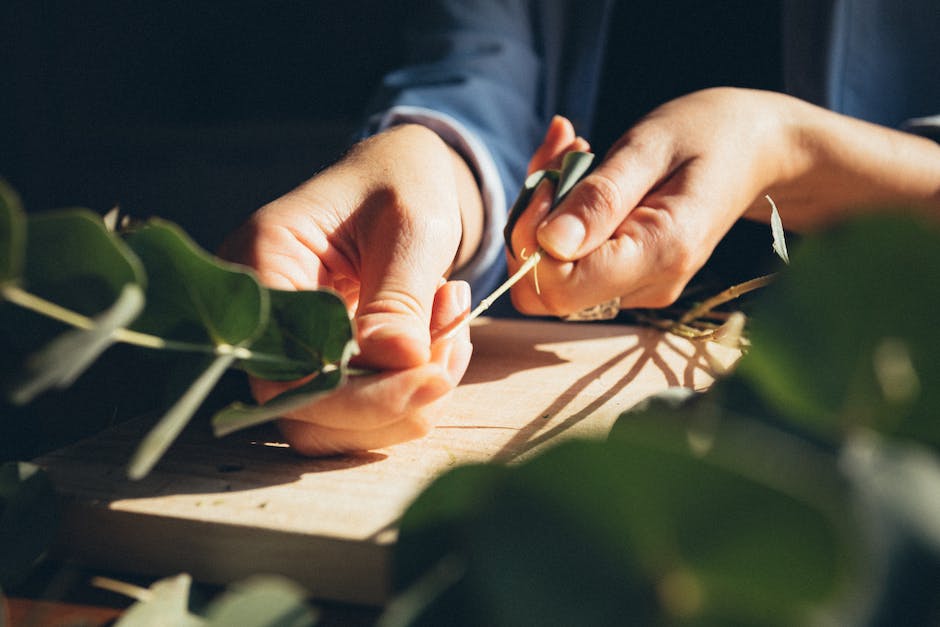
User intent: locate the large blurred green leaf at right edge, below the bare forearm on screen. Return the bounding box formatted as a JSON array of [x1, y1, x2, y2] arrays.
[[738, 216, 940, 447]]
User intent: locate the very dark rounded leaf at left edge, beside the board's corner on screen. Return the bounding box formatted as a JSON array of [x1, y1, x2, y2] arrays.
[[0, 462, 58, 587]]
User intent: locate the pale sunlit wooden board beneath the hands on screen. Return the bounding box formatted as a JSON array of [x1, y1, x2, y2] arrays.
[[38, 319, 737, 604]]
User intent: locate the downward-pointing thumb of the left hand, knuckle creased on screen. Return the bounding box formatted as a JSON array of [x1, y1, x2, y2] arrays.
[[356, 191, 460, 369]]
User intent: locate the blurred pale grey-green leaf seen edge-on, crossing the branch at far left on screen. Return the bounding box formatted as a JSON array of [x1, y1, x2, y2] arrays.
[[9, 283, 144, 404]]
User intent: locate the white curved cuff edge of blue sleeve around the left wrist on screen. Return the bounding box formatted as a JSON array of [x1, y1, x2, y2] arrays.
[[369, 105, 506, 296]]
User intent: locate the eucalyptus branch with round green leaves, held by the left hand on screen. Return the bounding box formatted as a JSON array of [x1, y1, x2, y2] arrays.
[[0, 181, 356, 478]]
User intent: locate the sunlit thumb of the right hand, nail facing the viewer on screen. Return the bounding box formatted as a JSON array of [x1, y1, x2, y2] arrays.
[[537, 129, 673, 261]]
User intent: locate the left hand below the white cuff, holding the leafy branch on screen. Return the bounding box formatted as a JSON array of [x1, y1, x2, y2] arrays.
[[220, 125, 482, 454]]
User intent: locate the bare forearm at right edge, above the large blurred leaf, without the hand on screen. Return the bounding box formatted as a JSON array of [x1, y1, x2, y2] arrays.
[[748, 97, 940, 231]]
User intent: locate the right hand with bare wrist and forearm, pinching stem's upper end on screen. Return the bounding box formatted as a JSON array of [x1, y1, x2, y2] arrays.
[[509, 88, 940, 315]]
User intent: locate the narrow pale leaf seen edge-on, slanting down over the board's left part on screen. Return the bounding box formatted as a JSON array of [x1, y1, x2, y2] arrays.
[[127, 353, 235, 479]]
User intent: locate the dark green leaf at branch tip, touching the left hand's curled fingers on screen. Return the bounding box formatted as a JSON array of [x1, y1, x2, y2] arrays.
[[240, 290, 354, 381]]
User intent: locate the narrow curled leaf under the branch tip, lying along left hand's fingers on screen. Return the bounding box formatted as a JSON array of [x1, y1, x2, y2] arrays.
[[212, 368, 345, 438]]
